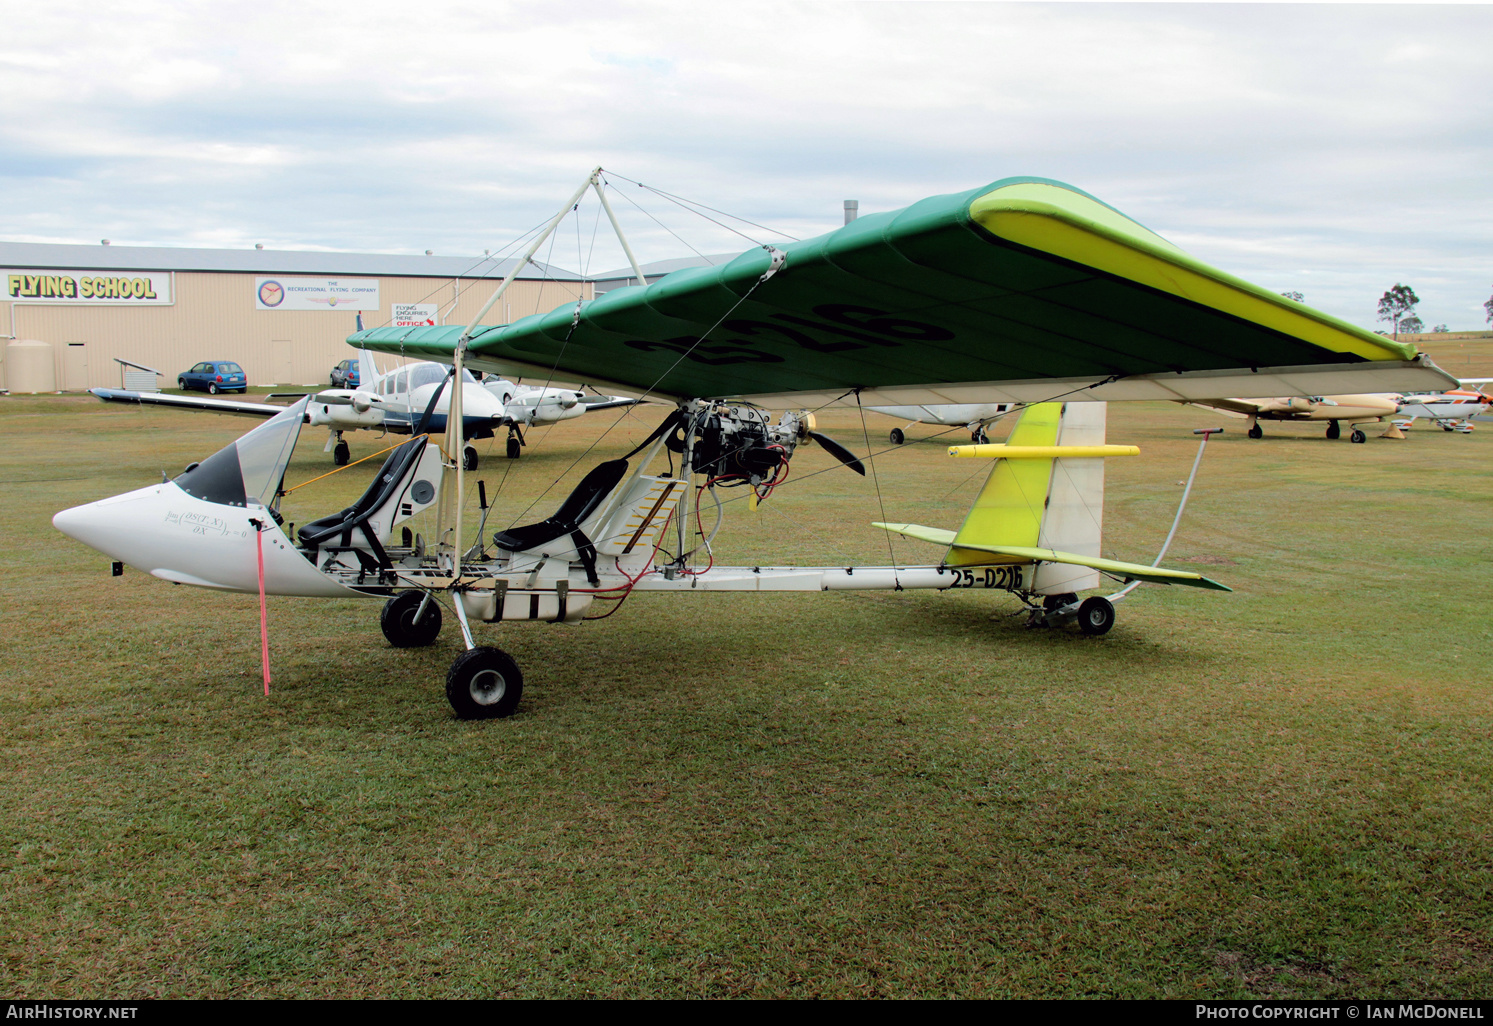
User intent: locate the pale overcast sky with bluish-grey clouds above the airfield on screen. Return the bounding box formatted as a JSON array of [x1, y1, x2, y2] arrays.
[[0, 0, 1493, 330]]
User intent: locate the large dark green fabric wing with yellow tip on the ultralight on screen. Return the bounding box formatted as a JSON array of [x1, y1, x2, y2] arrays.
[[348, 178, 1451, 406]]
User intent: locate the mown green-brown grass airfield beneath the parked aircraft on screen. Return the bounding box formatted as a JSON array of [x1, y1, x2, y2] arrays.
[[0, 397, 1493, 998]]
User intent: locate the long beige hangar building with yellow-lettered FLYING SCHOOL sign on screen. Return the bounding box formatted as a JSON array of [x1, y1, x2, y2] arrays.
[[0, 242, 606, 391]]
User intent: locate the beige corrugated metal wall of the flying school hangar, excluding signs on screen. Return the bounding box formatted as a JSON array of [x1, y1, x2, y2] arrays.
[[0, 272, 591, 388]]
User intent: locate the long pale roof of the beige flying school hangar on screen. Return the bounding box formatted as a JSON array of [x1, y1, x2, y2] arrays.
[[0, 242, 584, 281]]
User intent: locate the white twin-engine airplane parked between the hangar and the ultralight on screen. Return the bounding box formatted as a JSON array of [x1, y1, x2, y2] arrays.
[[90, 349, 636, 470]]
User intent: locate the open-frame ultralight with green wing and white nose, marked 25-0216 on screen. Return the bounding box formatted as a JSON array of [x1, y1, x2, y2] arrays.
[[54, 170, 1451, 718]]
